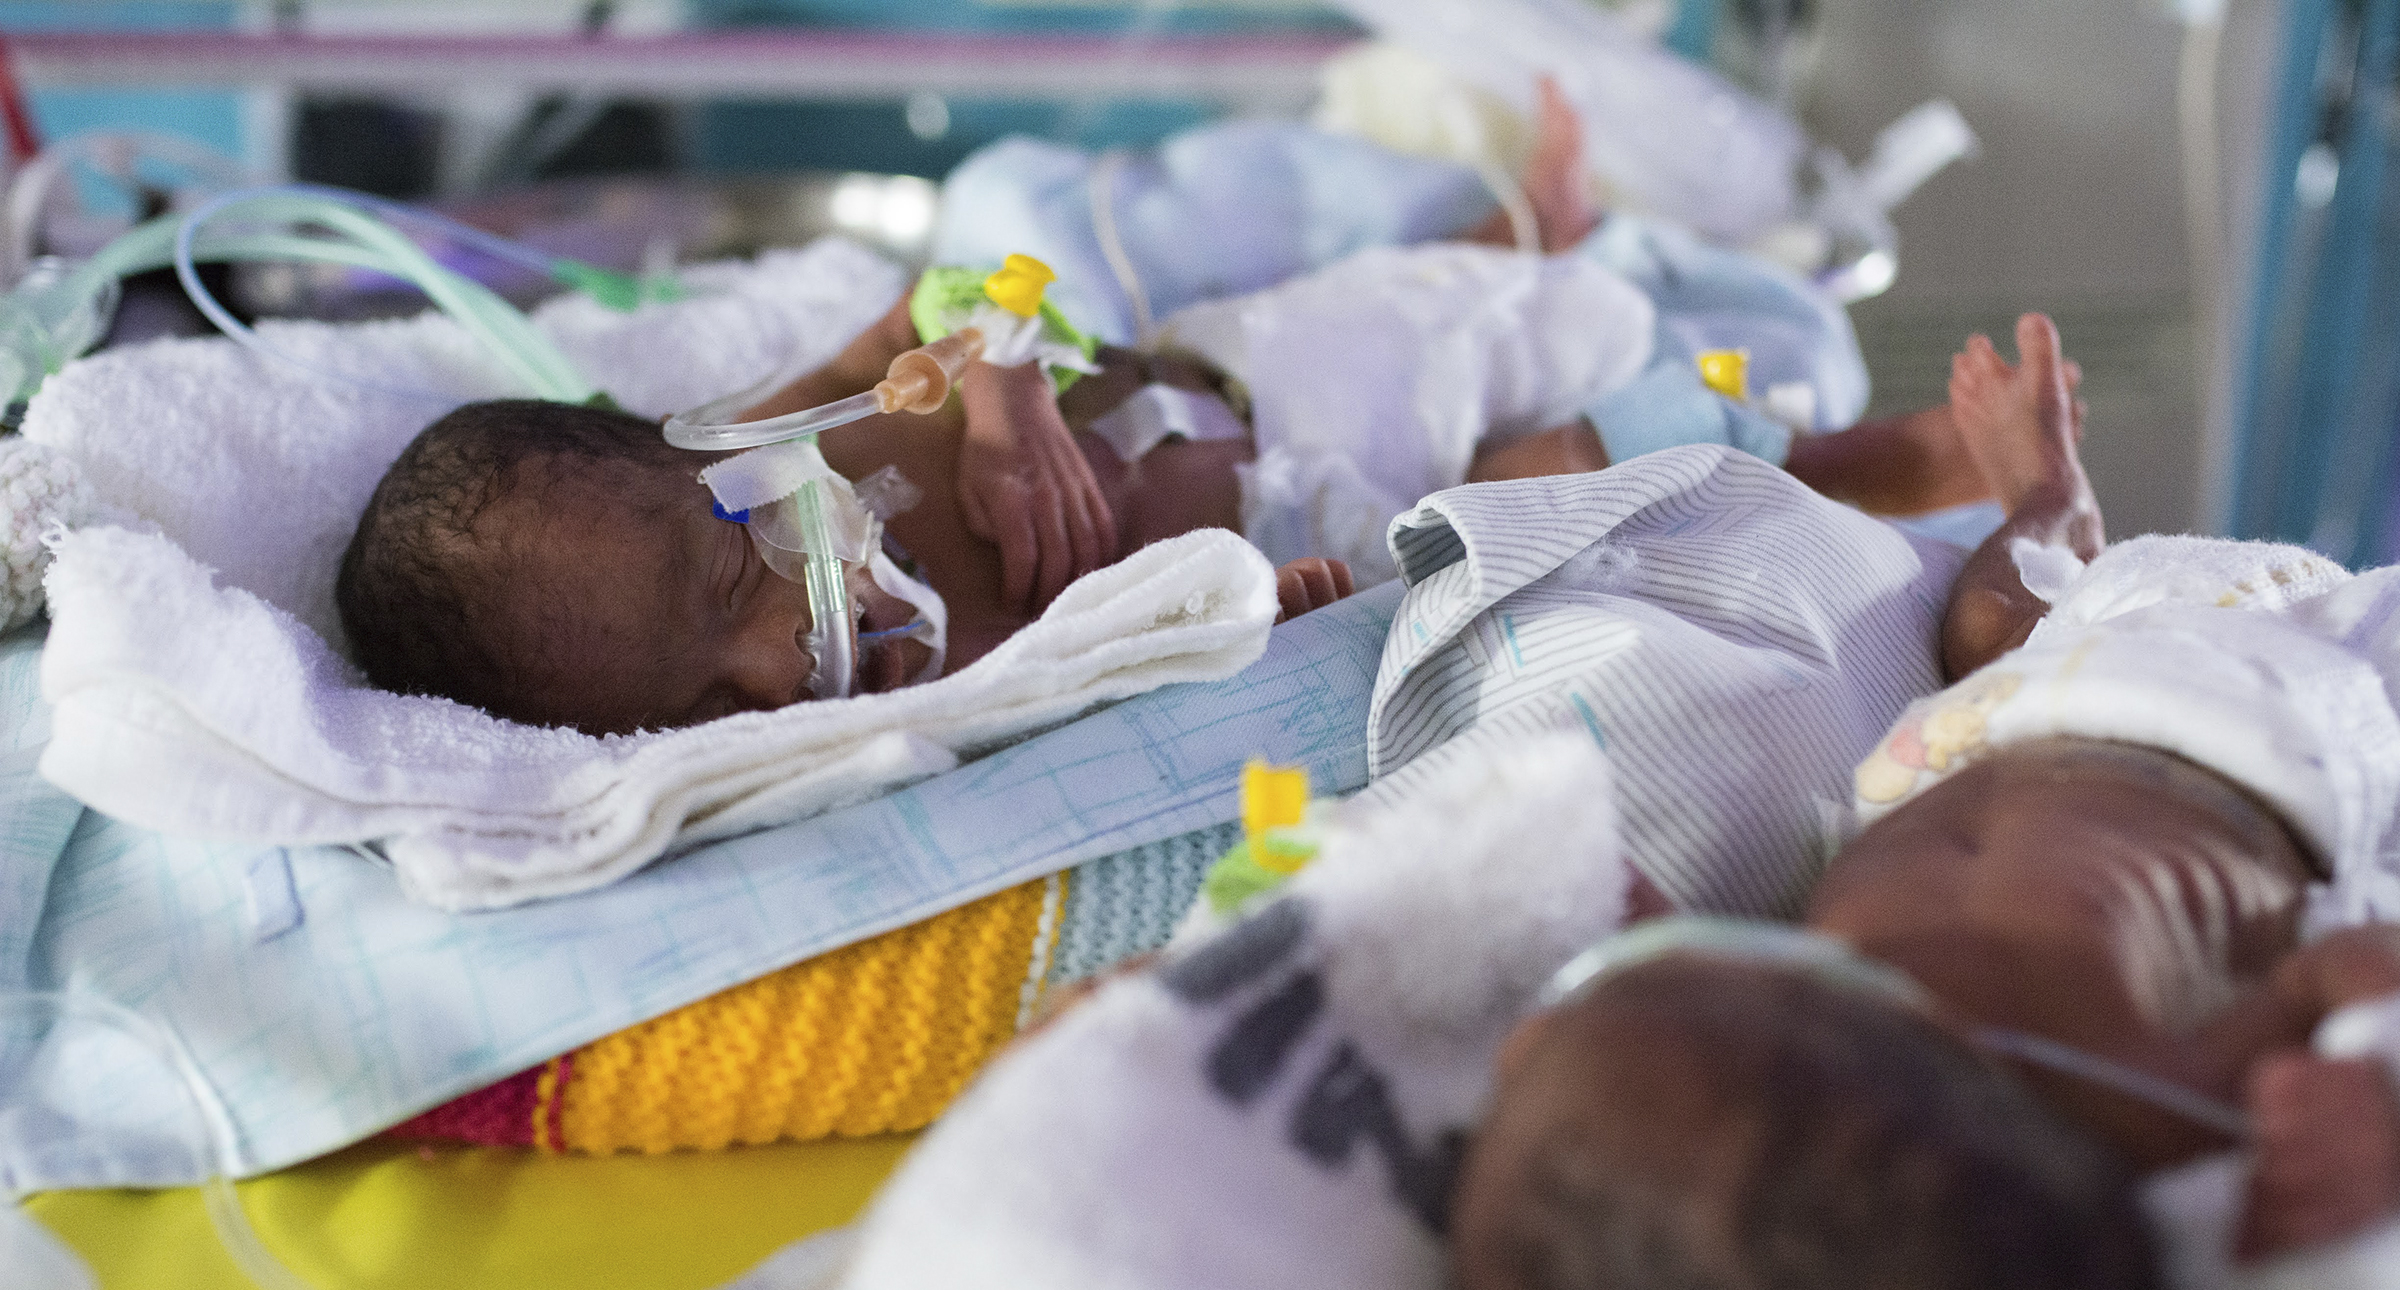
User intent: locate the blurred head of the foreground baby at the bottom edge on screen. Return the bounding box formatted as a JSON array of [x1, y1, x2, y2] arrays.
[[1452, 954, 2155, 1290]]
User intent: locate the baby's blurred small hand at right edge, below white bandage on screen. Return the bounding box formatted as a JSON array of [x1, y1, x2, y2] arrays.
[[2237, 1053, 2400, 1261]]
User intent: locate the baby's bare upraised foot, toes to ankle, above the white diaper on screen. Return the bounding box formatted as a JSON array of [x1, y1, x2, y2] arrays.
[[1951, 314, 2088, 513]]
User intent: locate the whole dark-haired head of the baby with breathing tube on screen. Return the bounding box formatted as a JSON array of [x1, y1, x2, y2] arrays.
[[334, 400, 907, 734]]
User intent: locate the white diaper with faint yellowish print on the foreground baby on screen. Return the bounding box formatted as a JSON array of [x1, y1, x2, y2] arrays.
[[1855, 537, 2400, 933]]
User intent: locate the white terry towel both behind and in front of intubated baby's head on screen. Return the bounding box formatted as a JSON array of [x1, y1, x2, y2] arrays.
[[26, 242, 1277, 909]]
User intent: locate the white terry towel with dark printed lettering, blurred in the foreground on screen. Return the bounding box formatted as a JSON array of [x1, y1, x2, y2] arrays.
[[842, 734, 1627, 1290]]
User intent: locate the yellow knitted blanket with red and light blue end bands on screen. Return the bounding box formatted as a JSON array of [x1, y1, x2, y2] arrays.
[[391, 822, 1241, 1153]]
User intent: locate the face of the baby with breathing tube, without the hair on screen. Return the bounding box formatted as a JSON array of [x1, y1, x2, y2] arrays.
[[475, 463, 926, 734]]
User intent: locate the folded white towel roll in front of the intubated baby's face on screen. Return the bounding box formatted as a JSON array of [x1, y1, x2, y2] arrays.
[[41, 517, 1277, 909]]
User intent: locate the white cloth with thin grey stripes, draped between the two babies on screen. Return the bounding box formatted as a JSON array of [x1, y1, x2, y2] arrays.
[[1368, 446, 1963, 918]]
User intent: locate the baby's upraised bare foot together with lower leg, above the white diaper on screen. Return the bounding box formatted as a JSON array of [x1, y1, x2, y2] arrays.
[[1942, 314, 2102, 681]]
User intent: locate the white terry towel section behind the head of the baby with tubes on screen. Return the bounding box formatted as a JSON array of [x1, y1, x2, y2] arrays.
[[24, 240, 907, 650]]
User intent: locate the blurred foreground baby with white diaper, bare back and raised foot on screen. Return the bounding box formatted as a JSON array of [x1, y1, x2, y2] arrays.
[[1454, 321, 2400, 1288]]
